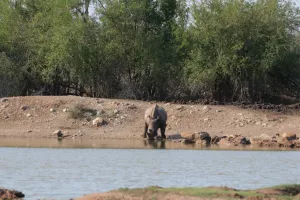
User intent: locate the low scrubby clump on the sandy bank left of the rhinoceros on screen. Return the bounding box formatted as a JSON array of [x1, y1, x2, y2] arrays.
[[69, 104, 97, 120]]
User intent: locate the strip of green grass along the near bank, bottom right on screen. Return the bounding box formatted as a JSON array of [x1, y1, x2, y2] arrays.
[[119, 184, 300, 200]]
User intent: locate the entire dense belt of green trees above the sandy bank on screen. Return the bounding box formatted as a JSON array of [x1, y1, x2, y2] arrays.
[[0, 0, 300, 102]]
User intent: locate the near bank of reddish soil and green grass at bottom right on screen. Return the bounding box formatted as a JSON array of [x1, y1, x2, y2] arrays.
[[75, 185, 300, 200]]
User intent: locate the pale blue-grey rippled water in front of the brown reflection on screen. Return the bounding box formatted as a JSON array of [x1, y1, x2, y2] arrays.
[[0, 140, 300, 199]]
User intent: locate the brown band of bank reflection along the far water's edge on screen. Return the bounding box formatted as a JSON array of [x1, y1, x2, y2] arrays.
[[0, 137, 299, 151]]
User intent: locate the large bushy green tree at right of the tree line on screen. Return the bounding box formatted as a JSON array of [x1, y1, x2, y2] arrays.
[[185, 0, 300, 101]]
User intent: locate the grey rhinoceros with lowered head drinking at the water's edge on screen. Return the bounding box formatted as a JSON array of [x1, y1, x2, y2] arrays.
[[143, 104, 168, 139]]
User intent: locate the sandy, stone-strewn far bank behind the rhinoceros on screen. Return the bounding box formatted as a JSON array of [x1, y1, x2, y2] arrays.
[[0, 96, 300, 147]]
